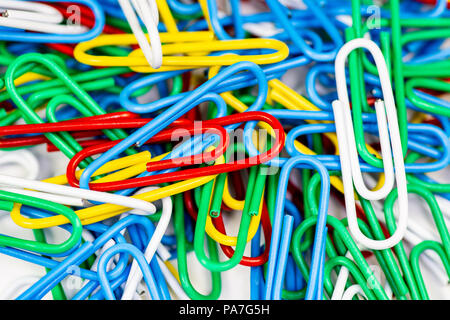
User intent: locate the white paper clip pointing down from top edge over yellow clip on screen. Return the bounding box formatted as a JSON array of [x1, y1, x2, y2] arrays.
[[119, 0, 162, 69]]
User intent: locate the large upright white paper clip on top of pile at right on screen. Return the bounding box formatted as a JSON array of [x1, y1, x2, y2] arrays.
[[332, 39, 408, 250]]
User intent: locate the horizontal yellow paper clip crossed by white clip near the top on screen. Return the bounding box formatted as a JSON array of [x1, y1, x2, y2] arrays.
[[74, 31, 289, 73]]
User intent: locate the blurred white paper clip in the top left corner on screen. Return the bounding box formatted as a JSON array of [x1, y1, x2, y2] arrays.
[[0, 0, 89, 34]]
